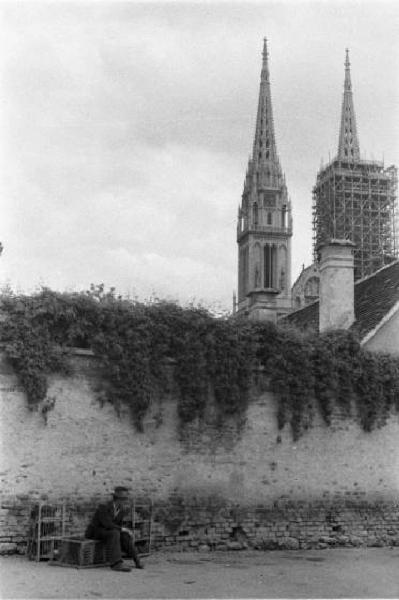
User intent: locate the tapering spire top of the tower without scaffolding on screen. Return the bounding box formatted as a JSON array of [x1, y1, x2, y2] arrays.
[[252, 38, 281, 184]]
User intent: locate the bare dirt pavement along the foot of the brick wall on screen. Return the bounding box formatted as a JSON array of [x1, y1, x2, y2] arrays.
[[0, 548, 399, 598]]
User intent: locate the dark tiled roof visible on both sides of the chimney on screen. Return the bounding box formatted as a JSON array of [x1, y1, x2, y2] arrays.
[[285, 260, 399, 339]]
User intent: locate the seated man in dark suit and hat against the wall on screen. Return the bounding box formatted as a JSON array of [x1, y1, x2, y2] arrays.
[[85, 486, 143, 571]]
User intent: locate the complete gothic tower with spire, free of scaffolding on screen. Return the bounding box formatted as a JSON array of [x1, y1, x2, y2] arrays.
[[237, 39, 292, 320]]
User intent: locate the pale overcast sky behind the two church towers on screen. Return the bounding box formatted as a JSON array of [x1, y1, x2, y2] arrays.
[[0, 0, 399, 308]]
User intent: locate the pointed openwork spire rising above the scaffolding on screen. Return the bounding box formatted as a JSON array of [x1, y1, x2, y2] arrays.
[[338, 48, 360, 160]]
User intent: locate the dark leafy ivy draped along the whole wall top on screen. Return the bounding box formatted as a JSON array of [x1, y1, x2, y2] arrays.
[[0, 285, 399, 439]]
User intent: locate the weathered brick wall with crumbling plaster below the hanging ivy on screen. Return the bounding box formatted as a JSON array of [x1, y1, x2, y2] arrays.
[[0, 357, 399, 551]]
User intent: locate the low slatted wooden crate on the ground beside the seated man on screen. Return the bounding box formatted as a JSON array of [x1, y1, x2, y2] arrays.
[[51, 538, 109, 568]]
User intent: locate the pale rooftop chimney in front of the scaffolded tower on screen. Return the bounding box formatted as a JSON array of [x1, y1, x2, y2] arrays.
[[319, 240, 355, 332]]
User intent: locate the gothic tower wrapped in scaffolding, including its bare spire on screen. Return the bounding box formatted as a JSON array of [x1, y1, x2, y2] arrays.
[[313, 50, 398, 279]]
